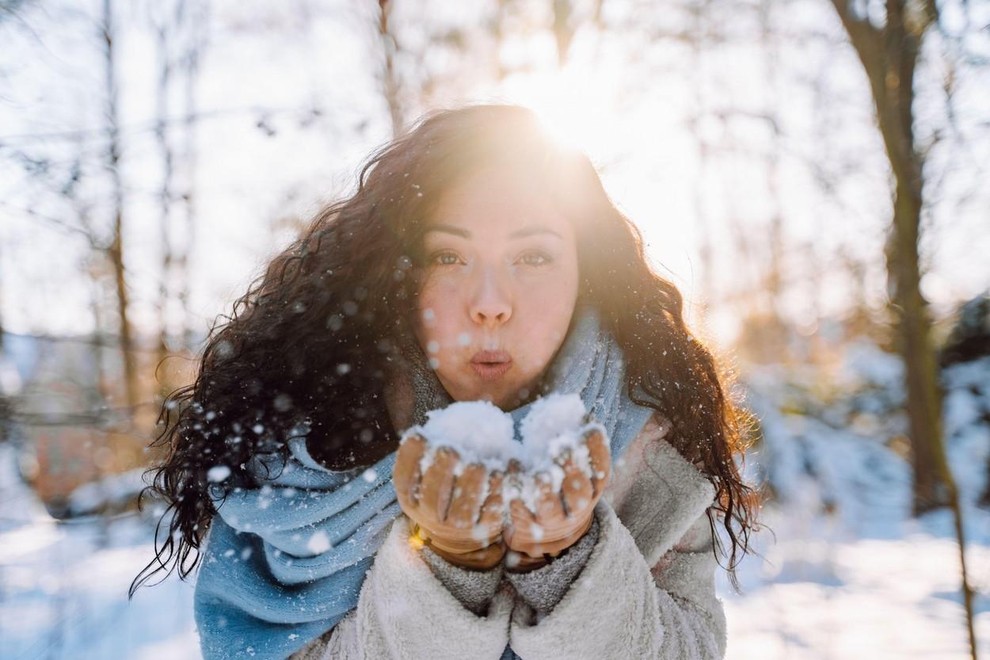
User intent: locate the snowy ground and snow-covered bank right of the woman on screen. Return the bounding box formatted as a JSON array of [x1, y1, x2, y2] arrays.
[[720, 345, 990, 660]]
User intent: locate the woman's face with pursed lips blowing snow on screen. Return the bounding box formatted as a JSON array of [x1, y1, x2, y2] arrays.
[[417, 169, 578, 410]]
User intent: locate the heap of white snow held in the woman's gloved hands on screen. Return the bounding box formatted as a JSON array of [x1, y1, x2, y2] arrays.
[[403, 394, 605, 512]]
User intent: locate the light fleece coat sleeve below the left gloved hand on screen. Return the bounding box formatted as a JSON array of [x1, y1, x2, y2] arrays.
[[323, 516, 512, 660]]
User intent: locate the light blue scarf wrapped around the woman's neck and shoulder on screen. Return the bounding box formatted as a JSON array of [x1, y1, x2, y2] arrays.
[[195, 308, 651, 659]]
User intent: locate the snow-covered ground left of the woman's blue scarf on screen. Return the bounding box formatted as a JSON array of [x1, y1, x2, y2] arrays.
[[0, 447, 198, 660]]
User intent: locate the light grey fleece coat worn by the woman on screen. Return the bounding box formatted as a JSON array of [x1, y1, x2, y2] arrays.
[[296, 423, 726, 660]]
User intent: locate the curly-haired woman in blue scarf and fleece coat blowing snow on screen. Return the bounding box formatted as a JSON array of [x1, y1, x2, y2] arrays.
[[136, 106, 755, 658]]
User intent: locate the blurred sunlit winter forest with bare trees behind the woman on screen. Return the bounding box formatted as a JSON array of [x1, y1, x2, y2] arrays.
[[0, 0, 990, 657]]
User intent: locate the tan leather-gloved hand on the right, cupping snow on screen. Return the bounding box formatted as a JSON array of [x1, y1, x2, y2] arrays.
[[503, 429, 612, 571]]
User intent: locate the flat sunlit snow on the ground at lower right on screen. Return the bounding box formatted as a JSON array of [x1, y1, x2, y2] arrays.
[[721, 512, 990, 660]]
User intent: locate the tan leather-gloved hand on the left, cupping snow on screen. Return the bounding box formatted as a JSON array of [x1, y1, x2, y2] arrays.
[[393, 436, 505, 570]]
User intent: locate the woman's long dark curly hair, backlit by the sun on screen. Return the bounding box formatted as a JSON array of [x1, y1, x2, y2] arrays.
[[131, 105, 756, 595]]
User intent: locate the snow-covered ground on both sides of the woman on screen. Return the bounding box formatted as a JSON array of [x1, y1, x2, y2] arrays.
[[0, 348, 990, 660]]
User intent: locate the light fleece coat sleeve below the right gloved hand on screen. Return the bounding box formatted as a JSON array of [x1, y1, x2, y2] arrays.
[[510, 502, 725, 660]]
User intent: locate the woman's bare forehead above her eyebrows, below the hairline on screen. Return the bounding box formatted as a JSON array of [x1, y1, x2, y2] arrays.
[[426, 169, 573, 236]]
